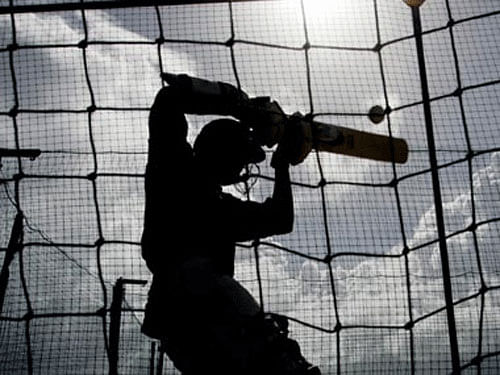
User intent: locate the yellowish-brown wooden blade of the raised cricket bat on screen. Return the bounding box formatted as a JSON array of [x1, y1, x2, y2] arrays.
[[313, 122, 408, 164]]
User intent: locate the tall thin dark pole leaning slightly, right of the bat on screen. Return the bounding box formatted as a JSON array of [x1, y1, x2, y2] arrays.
[[411, 6, 460, 374]]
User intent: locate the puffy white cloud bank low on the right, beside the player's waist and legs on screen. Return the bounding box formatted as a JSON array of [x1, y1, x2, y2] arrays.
[[231, 153, 500, 371]]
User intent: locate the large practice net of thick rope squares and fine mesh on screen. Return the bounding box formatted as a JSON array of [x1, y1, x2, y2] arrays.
[[0, 0, 500, 374]]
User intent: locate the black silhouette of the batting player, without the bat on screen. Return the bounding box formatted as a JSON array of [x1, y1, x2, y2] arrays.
[[142, 75, 319, 375]]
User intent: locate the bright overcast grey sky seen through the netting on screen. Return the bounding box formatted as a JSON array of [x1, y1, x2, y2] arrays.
[[0, 0, 500, 373]]
